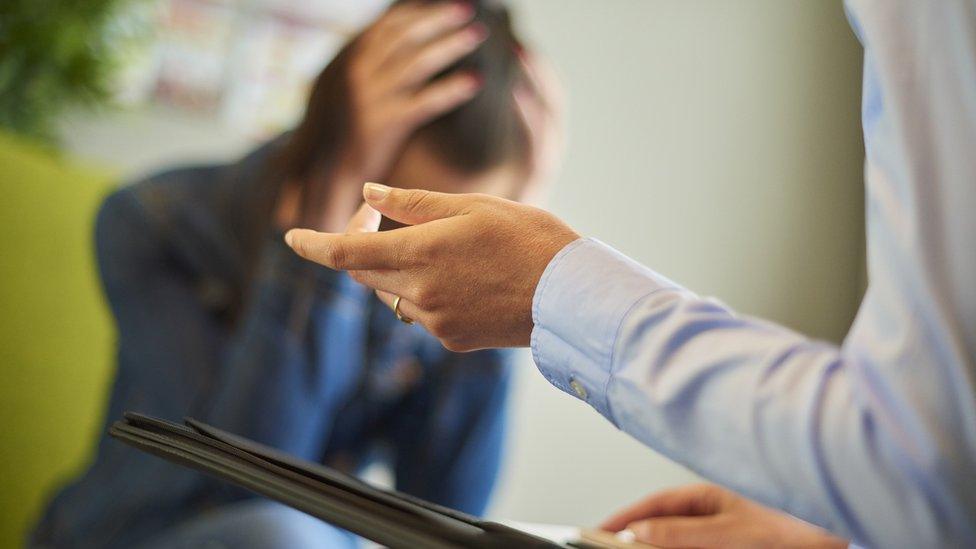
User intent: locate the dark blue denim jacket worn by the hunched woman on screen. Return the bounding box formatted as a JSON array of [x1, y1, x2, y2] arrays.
[[31, 145, 509, 547]]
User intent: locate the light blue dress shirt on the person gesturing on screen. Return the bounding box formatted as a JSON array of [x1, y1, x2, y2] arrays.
[[532, 0, 976, 547]]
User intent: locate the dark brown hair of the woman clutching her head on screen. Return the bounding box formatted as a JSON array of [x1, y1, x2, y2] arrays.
[[230, 0, 528, 326]]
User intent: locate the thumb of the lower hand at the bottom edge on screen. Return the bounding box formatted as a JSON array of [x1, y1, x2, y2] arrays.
[[627, 515, 728, 547]]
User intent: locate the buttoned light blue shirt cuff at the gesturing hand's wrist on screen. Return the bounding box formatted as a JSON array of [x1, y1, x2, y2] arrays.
[[531, 238, 682, 425]]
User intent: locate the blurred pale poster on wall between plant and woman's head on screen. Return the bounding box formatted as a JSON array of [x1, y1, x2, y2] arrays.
[[124, 0, 389, 139]]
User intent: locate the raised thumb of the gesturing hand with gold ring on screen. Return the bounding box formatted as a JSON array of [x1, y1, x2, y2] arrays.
[[363, 183, 476, 225]]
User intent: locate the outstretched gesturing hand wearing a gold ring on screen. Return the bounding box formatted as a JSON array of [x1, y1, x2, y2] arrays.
[[285, 183, 579, 351]]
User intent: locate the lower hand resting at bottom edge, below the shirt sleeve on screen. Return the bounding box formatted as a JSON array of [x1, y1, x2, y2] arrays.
[[600, 484, 848, 549]]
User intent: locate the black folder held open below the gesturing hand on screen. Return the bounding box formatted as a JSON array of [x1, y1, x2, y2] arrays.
[[109, 412, 562, 549]]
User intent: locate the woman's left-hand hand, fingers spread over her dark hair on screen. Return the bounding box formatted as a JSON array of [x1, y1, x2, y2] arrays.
[[340, 2, 487, 182]]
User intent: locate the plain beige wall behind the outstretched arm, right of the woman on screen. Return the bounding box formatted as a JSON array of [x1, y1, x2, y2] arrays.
[[494, 0, 863, 523]]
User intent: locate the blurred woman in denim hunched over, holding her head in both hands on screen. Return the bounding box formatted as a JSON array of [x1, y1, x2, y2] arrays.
[[32, 2, 553, 547]]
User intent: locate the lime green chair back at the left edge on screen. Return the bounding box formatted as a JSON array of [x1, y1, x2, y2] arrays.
[[0, 134, 115, 547]]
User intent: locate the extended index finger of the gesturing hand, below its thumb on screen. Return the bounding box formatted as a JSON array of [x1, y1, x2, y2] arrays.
[[285, 227, 416, 271]]
